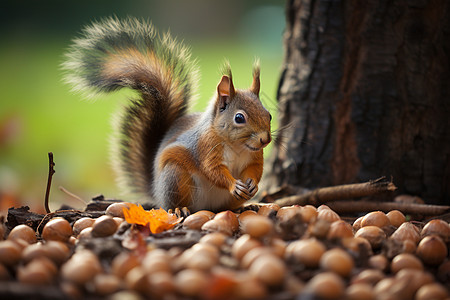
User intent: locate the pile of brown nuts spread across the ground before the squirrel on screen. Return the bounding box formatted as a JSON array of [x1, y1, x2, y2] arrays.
[[0, 203, 450, 300]]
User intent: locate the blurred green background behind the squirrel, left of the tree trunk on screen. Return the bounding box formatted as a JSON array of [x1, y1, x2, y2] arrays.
[[0, 0, 285, 214]]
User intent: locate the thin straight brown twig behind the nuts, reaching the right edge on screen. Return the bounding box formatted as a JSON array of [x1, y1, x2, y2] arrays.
[[327, 201, 450, 216]]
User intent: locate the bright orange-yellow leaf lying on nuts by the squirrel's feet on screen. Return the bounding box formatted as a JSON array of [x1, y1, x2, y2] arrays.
[[123, 204, 181, 233]]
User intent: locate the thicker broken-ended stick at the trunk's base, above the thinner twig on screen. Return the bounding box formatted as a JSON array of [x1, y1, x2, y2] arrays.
[[275, 177, 397, 206]]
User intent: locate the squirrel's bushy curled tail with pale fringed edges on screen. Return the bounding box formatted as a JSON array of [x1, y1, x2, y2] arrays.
[[63, 18, 197, 199]]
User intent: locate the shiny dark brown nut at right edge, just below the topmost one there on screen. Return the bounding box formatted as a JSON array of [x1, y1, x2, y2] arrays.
[[416, 235, 448, 266]]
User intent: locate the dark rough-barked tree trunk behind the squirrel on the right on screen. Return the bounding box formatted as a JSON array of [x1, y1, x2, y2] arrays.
[[264, 0, 450, 203]]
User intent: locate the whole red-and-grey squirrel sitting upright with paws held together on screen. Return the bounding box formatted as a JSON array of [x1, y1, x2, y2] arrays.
[[63, 17, 272, 212]]
